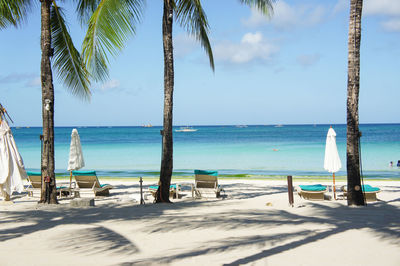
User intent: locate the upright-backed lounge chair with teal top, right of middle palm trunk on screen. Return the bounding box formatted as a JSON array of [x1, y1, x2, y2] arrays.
[[193, 170, 223, 198]]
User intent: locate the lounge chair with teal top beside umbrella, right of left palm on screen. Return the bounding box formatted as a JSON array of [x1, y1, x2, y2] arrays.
[[72, 171, 113, 196]]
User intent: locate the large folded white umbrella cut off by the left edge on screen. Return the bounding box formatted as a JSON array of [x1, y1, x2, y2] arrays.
[[0, 114, 27, 200]]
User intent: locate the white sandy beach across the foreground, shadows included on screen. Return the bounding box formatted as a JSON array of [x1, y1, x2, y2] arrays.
[[0, 180, 400, 266]]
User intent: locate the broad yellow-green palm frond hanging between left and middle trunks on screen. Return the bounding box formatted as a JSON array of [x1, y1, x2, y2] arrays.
[[82, 0, 145, 81]]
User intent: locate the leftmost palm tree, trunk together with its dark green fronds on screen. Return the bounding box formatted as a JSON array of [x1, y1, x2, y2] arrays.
[[0, 0, 90, 204]]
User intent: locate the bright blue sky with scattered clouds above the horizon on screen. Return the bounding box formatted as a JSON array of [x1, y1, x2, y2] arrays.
[[0, 0, 400, 126]]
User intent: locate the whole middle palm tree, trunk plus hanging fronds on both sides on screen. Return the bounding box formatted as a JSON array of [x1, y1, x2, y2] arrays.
[[80, 0, 274, 202]]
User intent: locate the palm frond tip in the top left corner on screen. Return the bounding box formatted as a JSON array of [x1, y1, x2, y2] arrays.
[[0, 0, 32, 29]]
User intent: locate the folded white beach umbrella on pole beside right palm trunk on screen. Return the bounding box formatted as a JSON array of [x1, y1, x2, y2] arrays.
[[324, 127, 342, 199]]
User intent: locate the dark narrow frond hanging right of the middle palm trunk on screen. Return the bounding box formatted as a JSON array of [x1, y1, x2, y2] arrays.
[[175, 0, 215, 71]]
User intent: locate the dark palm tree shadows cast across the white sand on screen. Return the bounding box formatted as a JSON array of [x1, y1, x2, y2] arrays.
[[0, 184, 400, 266]]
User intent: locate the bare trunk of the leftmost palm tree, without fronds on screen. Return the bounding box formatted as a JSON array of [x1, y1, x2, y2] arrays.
[[40, 0, 57, 204]]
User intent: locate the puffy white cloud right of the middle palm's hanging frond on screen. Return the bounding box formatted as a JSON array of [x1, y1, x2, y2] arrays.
[[214, 32, 278, 64]]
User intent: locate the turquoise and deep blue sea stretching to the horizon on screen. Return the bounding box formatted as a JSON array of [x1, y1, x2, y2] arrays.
[[12, 124, 400, 180]]
